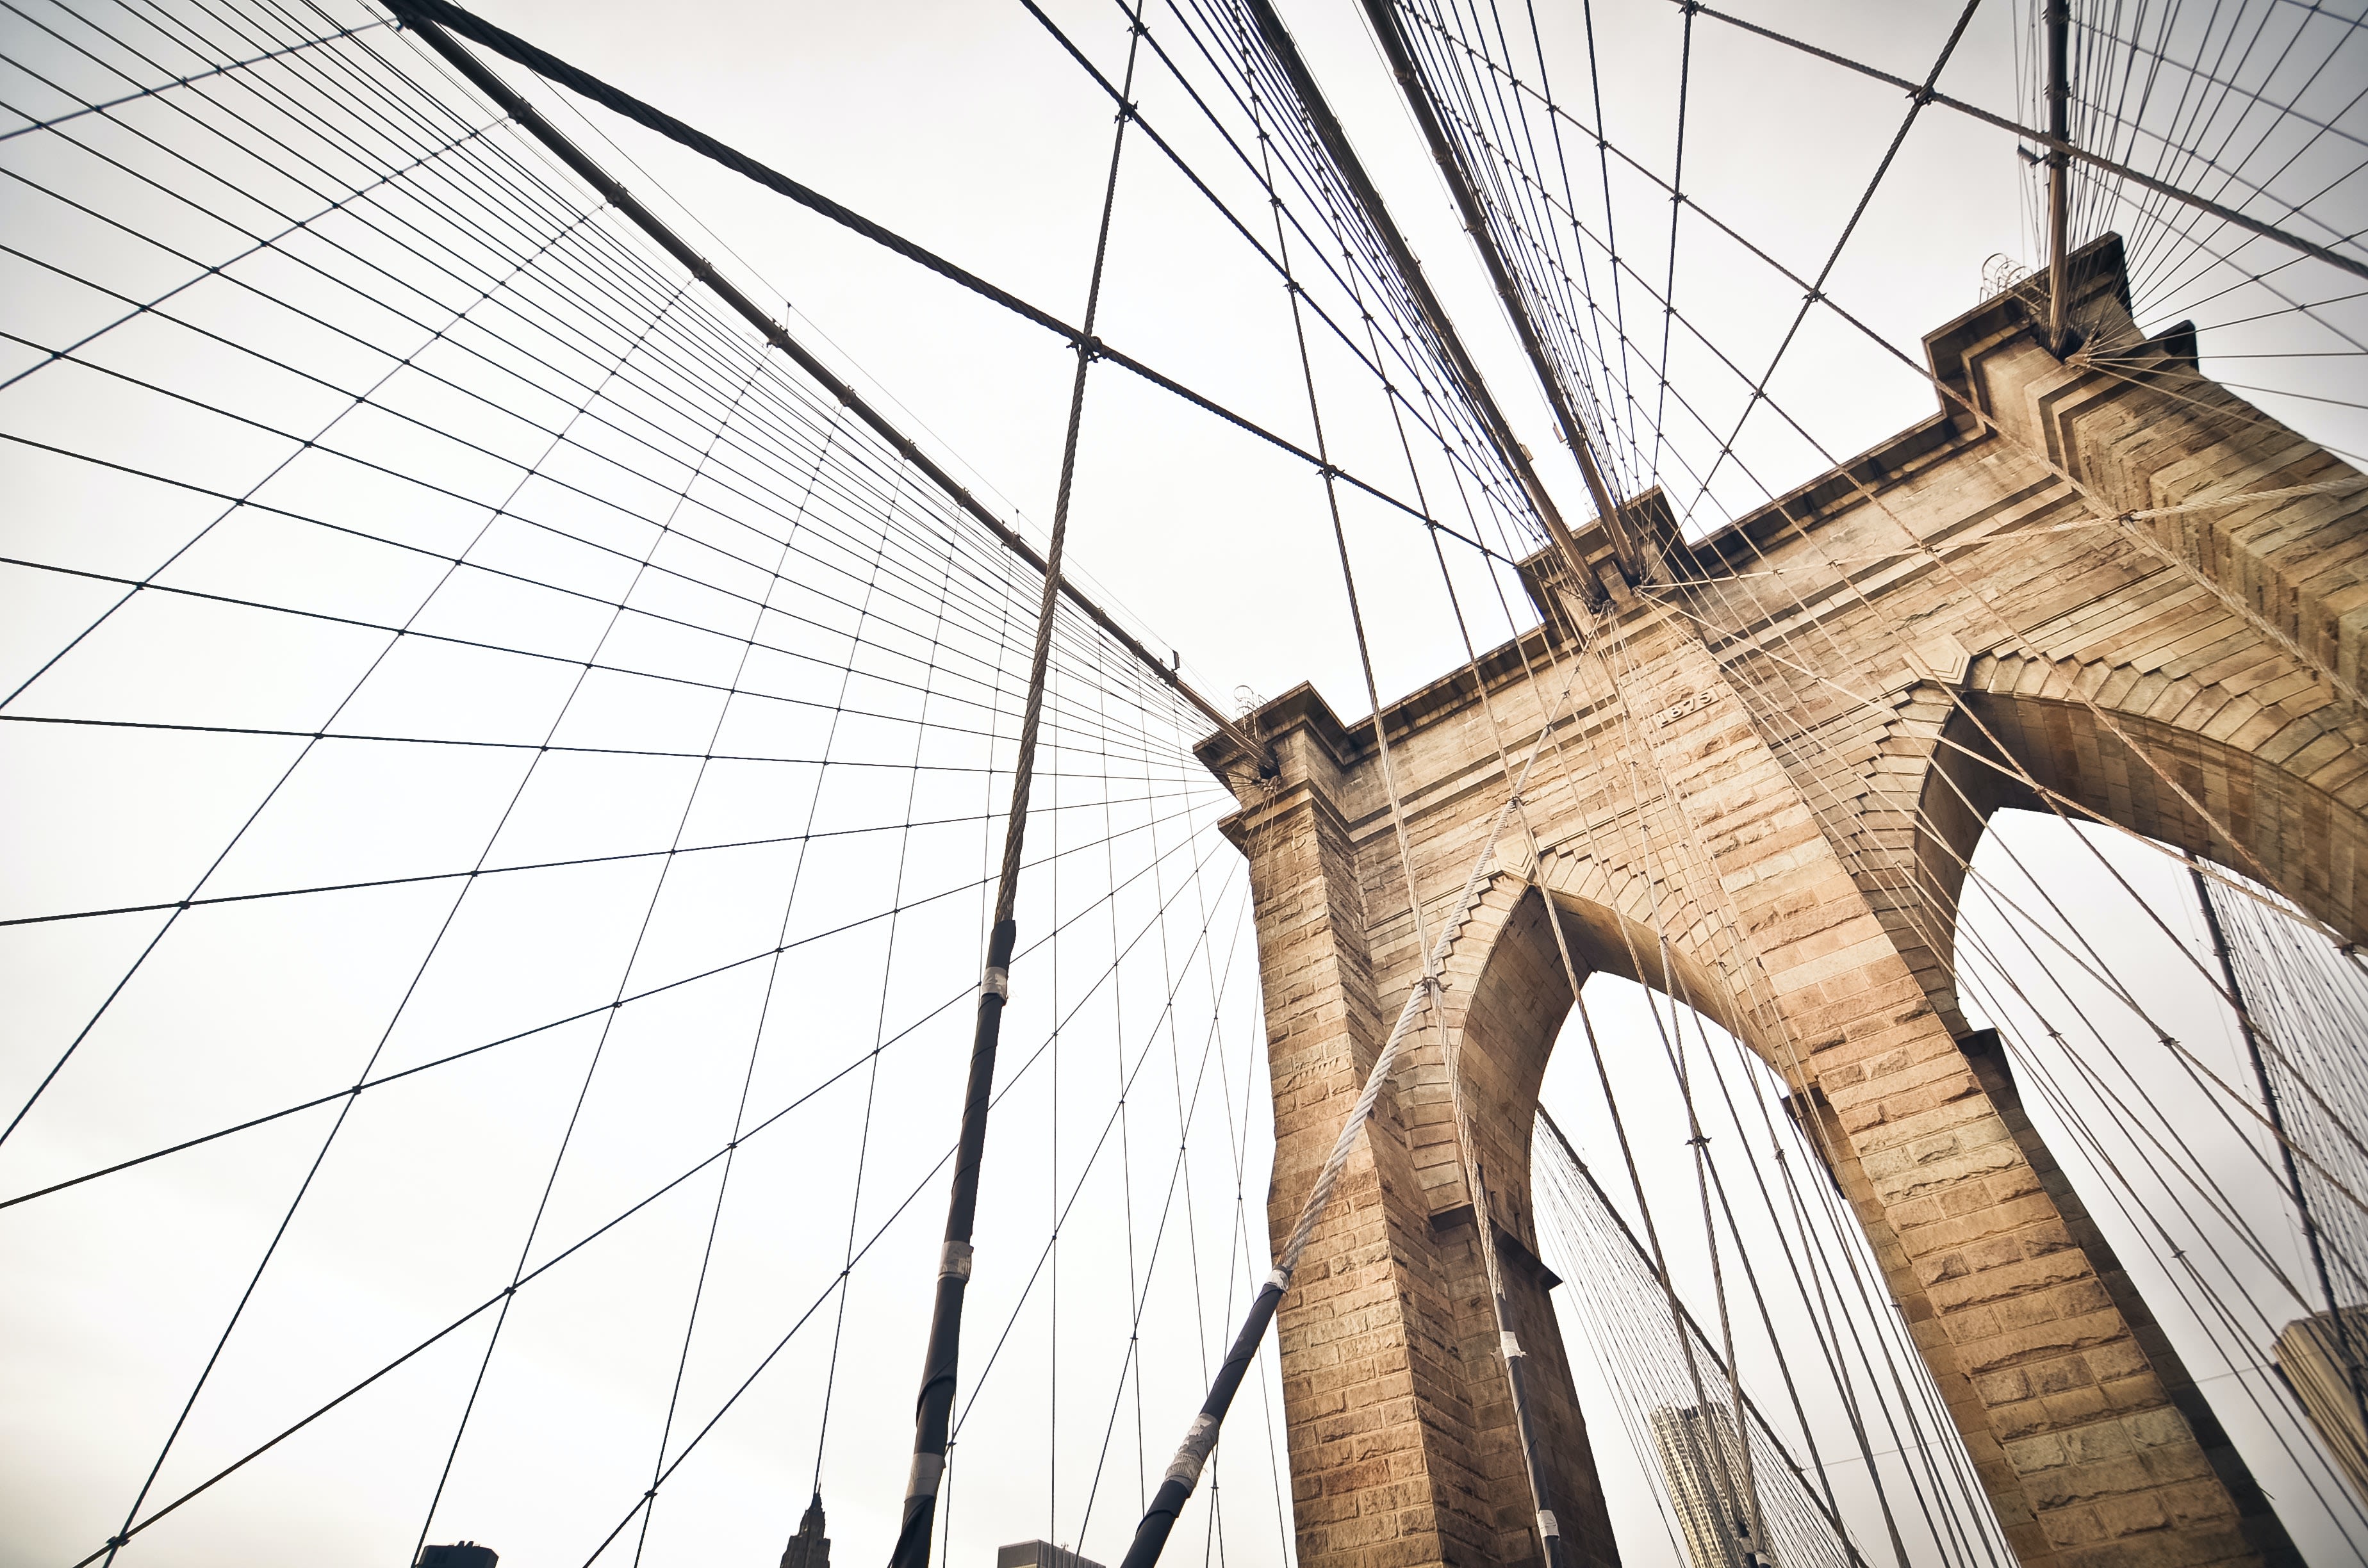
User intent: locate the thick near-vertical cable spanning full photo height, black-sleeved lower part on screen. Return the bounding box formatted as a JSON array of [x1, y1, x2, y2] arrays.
[[888, 0, 1144, 1568]]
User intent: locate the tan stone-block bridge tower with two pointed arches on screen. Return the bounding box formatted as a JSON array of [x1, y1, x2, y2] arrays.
[[1203, 237, 2368, 1568]]
